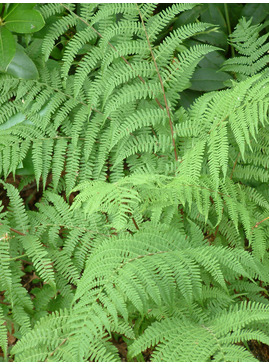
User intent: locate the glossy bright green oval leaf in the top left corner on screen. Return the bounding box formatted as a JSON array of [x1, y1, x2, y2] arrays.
[[5, 7, 45, 33]]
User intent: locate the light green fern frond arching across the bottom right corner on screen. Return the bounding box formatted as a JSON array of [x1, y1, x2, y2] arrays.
[[130, 304, 268, 361]]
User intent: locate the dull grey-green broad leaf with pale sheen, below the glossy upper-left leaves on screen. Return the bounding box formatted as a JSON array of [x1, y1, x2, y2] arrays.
[[6, 45, 38, 80]]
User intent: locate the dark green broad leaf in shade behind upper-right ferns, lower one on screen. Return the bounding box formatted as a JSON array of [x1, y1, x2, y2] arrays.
[[190, 67, 231, 91]]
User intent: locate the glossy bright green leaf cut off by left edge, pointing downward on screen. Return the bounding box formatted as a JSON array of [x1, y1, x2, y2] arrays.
[[0, 27, 16, 71]]
